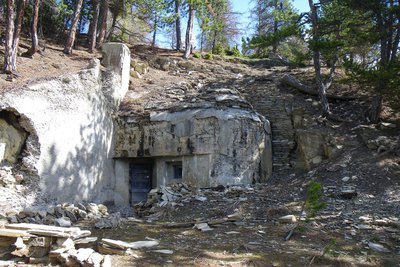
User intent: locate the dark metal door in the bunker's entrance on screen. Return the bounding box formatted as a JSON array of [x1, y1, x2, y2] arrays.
[[129, 164, 152, 203]]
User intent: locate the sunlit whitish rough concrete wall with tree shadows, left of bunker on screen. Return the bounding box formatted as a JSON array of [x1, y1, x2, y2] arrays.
[[0, 44, 130, 202]]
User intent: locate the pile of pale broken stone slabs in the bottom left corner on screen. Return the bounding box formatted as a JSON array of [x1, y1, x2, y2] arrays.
[[0, 223, 111, 267]]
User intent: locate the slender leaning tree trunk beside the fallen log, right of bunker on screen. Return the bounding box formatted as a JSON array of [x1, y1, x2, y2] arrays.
[[308, 0, 330, 117]]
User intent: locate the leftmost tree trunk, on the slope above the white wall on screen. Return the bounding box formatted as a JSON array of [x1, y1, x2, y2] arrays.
[[4, 0, 15, 73]]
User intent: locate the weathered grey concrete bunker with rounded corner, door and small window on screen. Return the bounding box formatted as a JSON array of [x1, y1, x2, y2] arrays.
[[114, 108, 272, 204]]
